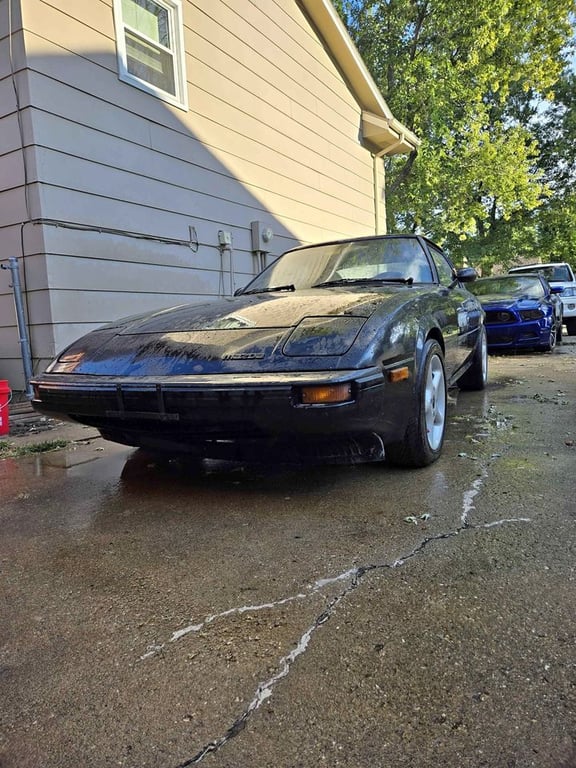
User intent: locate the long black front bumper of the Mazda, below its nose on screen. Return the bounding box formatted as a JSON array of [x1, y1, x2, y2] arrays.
[[32, 368, 413, 461]]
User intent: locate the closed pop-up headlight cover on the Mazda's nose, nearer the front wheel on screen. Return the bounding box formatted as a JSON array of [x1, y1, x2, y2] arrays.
[[282, 316, 366, 357]]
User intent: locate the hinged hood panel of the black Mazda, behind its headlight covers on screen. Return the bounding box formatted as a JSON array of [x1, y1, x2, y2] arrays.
[[120, 288, 402, 335]]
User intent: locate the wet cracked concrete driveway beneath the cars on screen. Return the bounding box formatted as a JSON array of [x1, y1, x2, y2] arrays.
[[0, 338, 576, 768]]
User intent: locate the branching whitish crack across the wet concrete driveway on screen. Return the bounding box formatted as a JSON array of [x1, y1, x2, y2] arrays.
[[162, 462, 531, 768]]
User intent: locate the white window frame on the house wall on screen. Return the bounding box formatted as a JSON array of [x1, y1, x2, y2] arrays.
[[114, 0, 188, 111]]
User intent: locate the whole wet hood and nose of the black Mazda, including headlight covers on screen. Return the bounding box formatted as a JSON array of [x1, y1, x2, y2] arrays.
[[52, 286, 412, 376]]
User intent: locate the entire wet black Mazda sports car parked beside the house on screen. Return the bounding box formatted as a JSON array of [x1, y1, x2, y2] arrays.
[[32, 235, 487, 467]]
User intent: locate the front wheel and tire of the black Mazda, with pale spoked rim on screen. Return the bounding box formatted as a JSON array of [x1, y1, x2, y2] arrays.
[[385, 339, 448, 468]]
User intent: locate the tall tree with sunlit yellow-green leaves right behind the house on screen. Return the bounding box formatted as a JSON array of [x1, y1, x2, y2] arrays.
[[335, 0, 576, 267]]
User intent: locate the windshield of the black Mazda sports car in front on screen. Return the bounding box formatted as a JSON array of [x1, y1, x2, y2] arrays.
[[242, 236, 434, 293]]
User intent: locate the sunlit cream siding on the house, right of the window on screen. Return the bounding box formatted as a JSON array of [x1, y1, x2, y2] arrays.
[[187, 1, 372, 234]]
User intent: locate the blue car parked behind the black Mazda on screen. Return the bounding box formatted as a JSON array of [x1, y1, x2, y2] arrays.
[[468, 274, 562, 352]]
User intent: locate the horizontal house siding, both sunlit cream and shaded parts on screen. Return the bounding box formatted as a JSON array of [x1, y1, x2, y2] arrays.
[[0, 0, 388, 390]]
